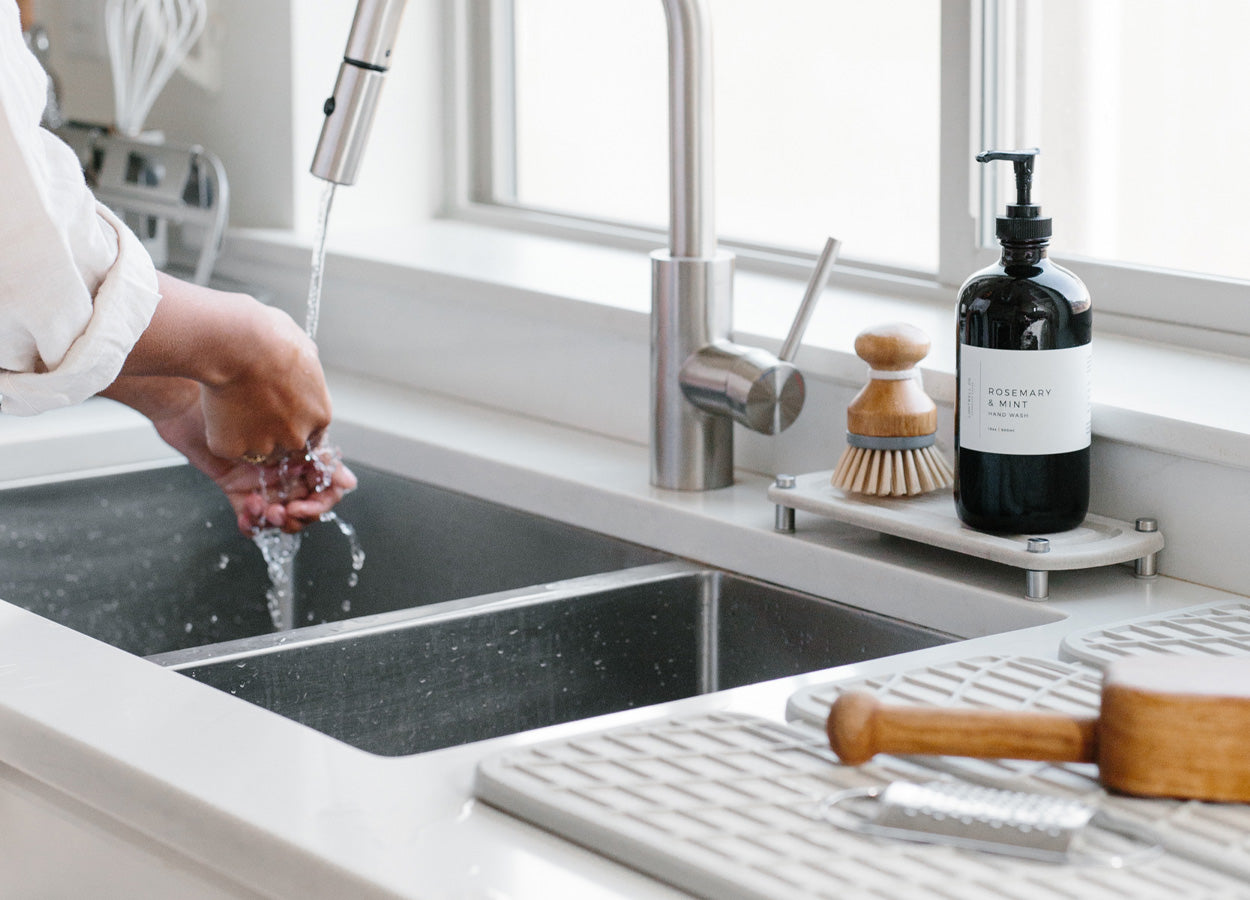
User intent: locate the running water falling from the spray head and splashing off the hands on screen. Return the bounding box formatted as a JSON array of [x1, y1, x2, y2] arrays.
[[251, 181, 365, 631]]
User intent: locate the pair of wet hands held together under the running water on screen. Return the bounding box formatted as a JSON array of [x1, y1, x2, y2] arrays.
[[103, 273, 356, 533]]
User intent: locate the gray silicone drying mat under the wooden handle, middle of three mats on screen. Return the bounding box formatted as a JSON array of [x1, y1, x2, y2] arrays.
[[786, 656, 1250, 880]]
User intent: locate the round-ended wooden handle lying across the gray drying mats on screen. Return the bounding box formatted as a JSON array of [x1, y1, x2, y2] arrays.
[[826, 691, 1098, 765]]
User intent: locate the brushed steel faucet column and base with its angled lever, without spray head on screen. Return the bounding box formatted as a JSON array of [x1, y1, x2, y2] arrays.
[[651, 0, 839, 490]]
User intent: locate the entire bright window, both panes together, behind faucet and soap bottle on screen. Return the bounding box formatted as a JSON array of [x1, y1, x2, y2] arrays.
[[464, 0, 1250, 349]]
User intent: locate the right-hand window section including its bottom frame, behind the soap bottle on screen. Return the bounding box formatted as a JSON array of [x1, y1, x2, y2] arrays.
[[984, 0, 1250, 345]]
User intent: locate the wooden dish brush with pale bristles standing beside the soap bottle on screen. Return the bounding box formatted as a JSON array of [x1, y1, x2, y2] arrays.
[[833, 323, 955, 496]]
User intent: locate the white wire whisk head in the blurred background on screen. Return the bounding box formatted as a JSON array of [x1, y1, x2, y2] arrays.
[[104, 0, 208, 138]]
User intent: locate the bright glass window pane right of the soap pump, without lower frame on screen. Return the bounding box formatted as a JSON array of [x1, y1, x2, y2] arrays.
[[999, 0, 1250, 279]]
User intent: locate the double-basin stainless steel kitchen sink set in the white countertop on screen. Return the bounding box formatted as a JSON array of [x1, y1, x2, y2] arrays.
[[0, 464, 953, 756]]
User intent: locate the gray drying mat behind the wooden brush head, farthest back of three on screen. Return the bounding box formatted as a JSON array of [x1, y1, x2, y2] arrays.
[[1060, 601, 1250, 666]]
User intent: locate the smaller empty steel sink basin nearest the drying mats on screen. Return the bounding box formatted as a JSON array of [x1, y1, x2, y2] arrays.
[[154, 563, 953, 756]]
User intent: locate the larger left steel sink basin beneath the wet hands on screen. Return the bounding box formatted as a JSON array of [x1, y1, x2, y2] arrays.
[[0, 464, 669, 656]]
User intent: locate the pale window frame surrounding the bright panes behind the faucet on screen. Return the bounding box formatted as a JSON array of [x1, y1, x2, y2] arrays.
[[445, 0, 1250, 355]]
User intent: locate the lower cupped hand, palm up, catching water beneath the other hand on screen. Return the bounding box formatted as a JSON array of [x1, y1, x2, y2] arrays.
[[104, 376, 356, 535]]
